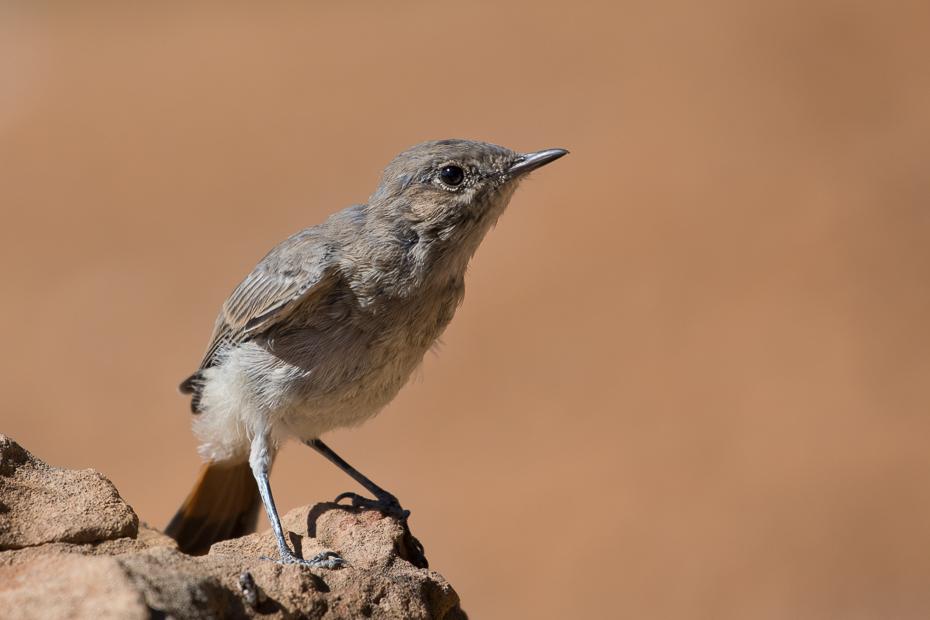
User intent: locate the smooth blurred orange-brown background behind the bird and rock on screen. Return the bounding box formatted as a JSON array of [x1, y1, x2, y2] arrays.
[[0, 0, 930, 619]]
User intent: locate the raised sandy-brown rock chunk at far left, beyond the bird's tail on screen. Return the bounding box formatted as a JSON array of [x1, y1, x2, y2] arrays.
[[0, 435, 139, 550]]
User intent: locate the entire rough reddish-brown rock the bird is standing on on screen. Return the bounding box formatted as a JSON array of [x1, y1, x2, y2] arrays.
[[0, 435, 466, 620]]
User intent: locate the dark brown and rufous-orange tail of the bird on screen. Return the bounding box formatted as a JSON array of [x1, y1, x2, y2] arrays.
[[165, 462, 261, 555]]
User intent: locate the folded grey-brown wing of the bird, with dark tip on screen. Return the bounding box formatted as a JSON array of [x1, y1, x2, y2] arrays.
[[178, 228, 335, 413]]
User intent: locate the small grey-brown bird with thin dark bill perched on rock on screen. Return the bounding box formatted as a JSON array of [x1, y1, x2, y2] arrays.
[[165, 140, 568, 568]]
